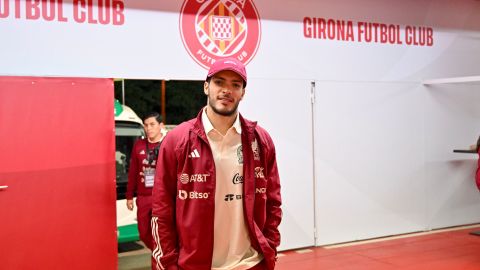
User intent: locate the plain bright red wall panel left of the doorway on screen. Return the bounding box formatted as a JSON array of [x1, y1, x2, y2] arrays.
[[0, 77, 117, 269]]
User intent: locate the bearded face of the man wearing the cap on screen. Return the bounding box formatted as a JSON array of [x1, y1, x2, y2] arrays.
[[204, 70, 245, 116]]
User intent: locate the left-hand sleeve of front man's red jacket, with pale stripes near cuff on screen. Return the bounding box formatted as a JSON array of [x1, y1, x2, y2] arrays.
[[151, 134, 178, 270]]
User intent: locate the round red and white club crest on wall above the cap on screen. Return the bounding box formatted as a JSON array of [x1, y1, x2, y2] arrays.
[[180, 0, 261, 69]]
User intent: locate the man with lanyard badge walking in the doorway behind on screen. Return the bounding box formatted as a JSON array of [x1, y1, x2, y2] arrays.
[[125, 112, 164, 250]]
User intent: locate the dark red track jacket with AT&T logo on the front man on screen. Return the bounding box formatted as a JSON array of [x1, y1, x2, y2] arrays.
[[152, 111, 282, 270]]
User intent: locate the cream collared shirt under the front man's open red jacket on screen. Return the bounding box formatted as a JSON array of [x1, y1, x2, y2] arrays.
[[202, 109, 263, 270]]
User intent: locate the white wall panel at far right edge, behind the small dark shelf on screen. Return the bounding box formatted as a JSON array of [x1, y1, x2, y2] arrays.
[[425, 83, 480, 229]]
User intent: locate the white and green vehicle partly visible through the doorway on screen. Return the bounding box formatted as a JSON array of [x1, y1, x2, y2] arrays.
[[115, 100, 145, 243]]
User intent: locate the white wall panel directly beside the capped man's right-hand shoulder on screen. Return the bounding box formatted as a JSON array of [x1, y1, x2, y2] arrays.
[[240, 79, 314, 250]]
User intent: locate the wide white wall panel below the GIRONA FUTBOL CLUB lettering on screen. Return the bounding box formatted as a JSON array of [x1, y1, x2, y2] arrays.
[[315, 81, 426, 245]]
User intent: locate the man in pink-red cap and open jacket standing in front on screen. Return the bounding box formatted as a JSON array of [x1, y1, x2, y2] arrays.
[[152, 58, 282, 270]]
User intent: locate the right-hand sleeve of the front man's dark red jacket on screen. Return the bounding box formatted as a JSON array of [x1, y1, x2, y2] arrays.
[[263, 135, 282, 250]]
